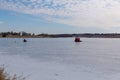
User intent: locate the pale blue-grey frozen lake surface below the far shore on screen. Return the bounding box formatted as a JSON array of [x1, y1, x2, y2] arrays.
[[0, 38, 120, 80]]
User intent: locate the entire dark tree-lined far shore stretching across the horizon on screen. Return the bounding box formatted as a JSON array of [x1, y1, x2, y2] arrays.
[[0, 31, 120, 38]]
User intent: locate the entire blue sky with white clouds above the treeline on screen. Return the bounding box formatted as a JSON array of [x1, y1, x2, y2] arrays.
[[0, 0, 120, 33]]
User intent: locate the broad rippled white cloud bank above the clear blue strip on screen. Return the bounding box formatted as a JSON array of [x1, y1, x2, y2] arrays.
[[0, 0, 120, 29]]
